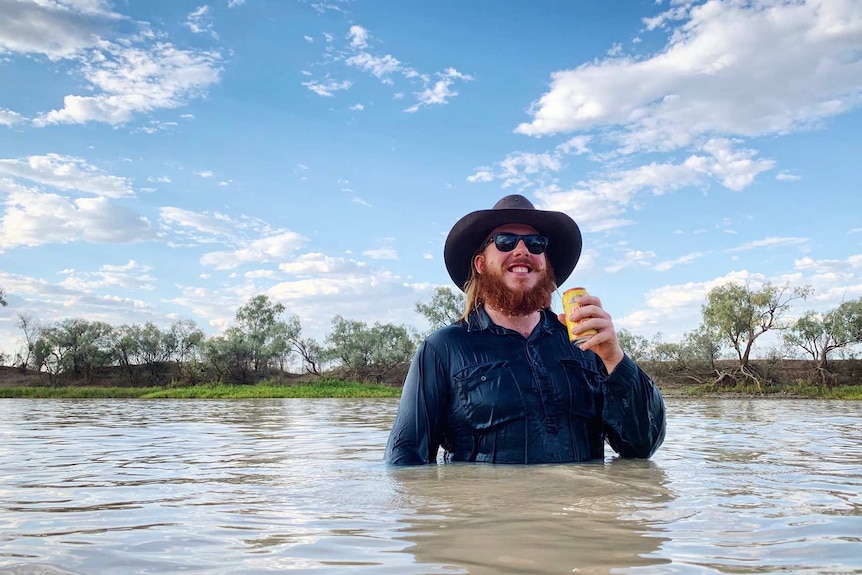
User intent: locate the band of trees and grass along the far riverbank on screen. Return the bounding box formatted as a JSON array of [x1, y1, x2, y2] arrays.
[[0, 283, 862, 397]]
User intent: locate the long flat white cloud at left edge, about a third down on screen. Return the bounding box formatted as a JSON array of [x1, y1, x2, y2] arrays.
[[0, 154, 134, 198]]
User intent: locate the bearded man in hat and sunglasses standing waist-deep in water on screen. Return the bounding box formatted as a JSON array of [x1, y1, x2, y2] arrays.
[[386, 195, 665, 465]]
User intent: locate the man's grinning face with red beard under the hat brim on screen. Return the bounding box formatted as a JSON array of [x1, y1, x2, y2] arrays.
[[473, 224, 555, 315]]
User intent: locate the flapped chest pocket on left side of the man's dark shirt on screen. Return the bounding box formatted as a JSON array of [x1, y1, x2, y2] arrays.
[[453, 361, 527, 431]]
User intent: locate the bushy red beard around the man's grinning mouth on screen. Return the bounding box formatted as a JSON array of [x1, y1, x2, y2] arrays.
[[476, 262, 557, 316]]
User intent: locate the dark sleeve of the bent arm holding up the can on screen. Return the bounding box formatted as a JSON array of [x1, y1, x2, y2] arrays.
[[602, 355, 666, 458]]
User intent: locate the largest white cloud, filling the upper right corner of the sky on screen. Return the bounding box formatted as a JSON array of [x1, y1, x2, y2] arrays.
[[517, 0, 862, 153]]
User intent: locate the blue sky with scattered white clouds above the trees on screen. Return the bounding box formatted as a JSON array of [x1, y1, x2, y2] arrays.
[[0, 0, 862, 360]]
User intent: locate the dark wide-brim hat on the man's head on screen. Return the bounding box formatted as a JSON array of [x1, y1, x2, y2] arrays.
[[443, 194, 582, 291]]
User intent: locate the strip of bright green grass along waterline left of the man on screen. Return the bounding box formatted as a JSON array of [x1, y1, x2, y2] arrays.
[[0, 380, 401, 399]]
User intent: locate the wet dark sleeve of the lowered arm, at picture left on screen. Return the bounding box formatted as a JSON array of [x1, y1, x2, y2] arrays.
[[385, 341, 449, 465]]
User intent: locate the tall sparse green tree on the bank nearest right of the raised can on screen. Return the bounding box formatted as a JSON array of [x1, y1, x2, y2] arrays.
[[702, 282, 811, 375]]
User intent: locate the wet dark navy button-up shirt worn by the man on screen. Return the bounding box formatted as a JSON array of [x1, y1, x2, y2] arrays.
[[386, 308, 665, 465]]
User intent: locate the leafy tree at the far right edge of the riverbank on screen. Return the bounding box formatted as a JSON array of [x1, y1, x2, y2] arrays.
[[784, 298, 862, 385]]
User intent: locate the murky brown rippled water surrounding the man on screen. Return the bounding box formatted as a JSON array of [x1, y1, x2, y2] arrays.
[[0, 400, 862, 575]]
